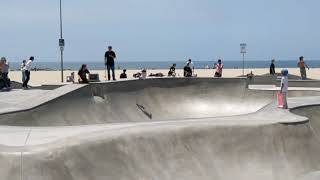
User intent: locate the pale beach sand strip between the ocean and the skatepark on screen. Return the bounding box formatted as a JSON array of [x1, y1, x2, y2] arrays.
[[9, 68, 320, 86]]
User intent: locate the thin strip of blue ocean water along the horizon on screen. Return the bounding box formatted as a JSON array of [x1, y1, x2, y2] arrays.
[[6, 60, 320, 70]]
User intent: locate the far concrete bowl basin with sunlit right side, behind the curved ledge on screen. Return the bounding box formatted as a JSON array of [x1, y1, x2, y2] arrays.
[[0, 79, 319, 126]]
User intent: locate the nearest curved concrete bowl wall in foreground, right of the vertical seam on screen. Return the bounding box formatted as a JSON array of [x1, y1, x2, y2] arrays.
[[13, 104, 320, 180]]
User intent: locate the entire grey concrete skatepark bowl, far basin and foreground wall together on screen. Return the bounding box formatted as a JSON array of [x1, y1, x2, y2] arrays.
[[0, 78, 320, 180]]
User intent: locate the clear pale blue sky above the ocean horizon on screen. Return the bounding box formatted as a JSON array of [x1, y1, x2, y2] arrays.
[[0, 0, 320, 62]]
